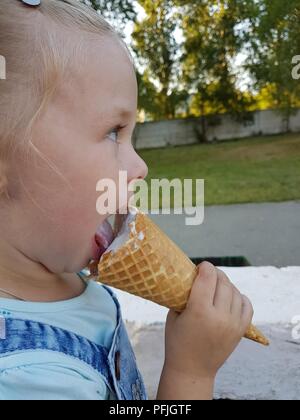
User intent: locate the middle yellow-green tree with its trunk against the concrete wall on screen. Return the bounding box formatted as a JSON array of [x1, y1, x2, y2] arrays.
[[177, 0, 252, 139]]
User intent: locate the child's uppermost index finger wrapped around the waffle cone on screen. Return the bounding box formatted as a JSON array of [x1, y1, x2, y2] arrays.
[[188, 261, 218, 307]]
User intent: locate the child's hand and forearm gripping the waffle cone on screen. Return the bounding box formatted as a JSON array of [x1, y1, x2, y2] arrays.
[[159, 262, 253, 399]]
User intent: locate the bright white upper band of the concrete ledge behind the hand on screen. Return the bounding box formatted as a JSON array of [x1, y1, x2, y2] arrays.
[[116, 267, 300, 325]]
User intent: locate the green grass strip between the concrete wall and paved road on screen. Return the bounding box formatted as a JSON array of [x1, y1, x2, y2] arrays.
[[139, 134, 300, 205]]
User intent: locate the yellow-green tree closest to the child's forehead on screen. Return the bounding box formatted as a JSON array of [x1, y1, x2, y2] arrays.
[[132, 0, 186, 119]]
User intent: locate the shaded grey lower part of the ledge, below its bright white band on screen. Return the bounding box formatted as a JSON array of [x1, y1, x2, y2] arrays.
[[128, 325, 300, 400]]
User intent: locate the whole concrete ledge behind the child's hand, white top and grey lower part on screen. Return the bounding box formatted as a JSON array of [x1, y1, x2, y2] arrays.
[[117, 267, 300, 400]]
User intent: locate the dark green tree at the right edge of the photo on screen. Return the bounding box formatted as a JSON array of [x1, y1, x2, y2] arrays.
[[249, 0, 300, 131]]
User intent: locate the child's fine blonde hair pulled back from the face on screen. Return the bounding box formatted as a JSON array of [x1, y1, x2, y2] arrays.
[[0, 0, 119, 199]]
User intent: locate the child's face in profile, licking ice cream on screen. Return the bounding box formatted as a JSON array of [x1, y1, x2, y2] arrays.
[[9, 35, 147, 273]]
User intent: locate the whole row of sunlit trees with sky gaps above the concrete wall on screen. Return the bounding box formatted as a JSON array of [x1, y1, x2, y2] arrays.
[[85, 0, 300, 126]]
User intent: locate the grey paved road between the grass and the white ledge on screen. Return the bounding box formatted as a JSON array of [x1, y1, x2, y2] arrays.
[[151, 201, 300, 267]]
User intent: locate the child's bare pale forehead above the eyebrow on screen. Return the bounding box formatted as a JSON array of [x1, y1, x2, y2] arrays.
[[49, 40, 137, 118]]
